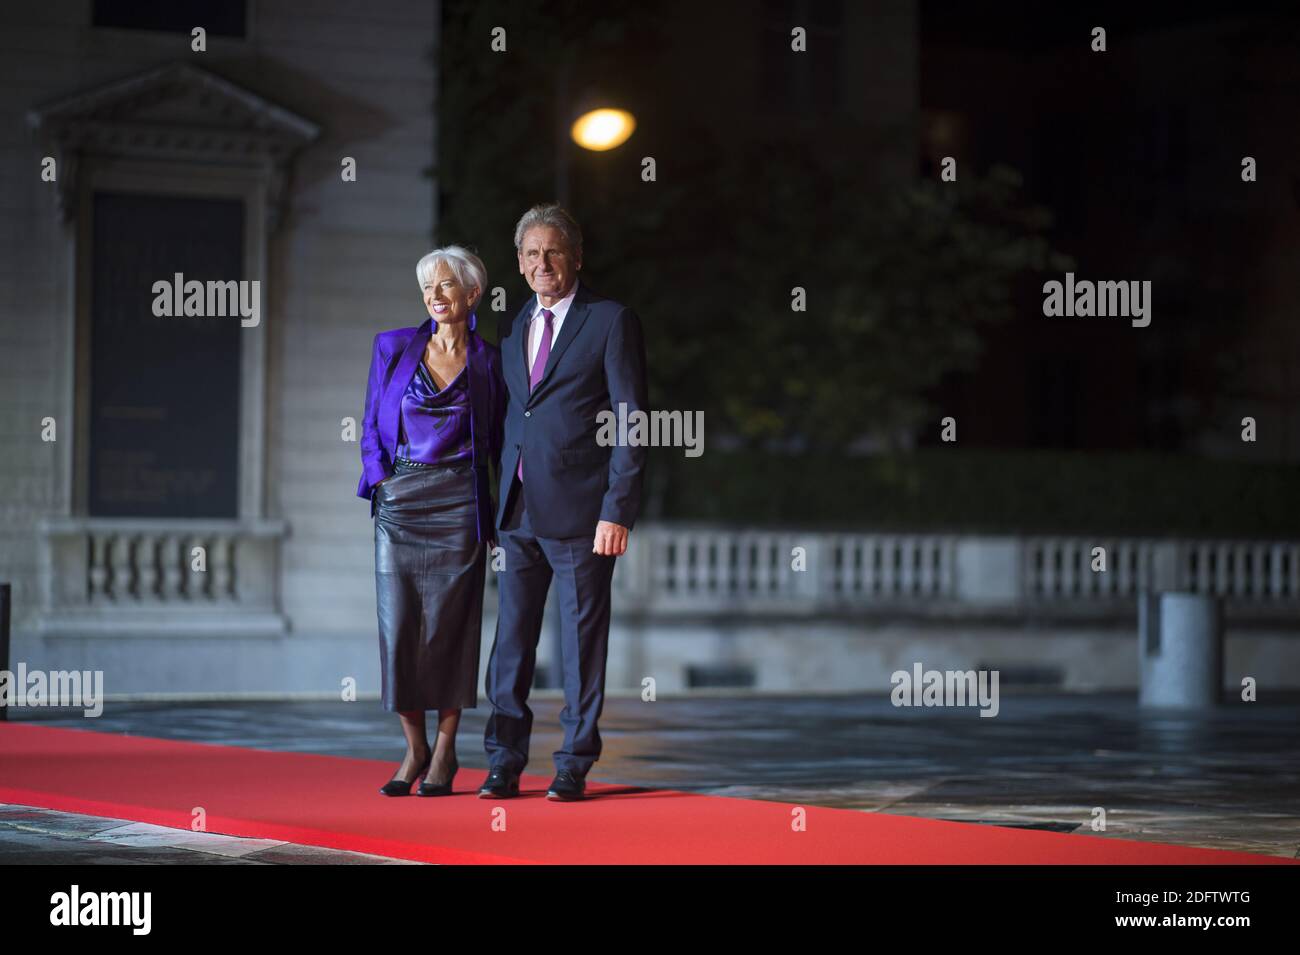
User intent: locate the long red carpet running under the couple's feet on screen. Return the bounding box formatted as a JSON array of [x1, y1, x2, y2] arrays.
[[0, 722, 1291, 865]]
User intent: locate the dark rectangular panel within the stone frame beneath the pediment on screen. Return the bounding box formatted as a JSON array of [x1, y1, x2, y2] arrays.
[[88, 192, 243, 517]]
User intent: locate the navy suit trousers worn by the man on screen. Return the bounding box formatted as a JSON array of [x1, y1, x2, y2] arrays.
[[484, 478, 618, 778]]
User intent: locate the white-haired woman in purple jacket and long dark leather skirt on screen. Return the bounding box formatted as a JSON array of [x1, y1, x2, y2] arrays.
[[356, 246, 506, 795]]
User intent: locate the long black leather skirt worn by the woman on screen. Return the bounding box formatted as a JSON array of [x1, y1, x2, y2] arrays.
[[374, 461, 488, 711]]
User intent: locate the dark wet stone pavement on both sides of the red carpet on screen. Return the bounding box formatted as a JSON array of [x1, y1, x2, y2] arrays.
[[0, 693, 1300, 864]]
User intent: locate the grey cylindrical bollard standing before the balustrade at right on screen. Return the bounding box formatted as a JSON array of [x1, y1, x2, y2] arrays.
[[1138, 591, 1223, 708]]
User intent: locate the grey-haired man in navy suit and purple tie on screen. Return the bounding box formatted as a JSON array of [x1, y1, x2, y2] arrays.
[[478, 204, 646, 800]]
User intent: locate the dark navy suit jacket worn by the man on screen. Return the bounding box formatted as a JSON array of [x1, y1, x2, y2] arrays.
[[497, 282, 647, 538]]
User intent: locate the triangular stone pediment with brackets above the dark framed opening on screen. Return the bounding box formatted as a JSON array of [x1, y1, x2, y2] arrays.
[[27, 62, 320, 230]]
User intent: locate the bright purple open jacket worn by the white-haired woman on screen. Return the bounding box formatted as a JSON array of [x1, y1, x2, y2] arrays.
[[356, 318, 506, 541]]
